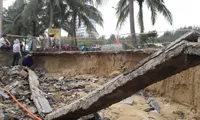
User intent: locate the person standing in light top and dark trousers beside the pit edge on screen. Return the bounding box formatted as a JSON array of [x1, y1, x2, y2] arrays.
[[12, 39, 22, 66]]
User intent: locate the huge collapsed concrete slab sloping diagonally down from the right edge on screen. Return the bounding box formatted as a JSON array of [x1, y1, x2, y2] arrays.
[[45, 32, 200, 120]]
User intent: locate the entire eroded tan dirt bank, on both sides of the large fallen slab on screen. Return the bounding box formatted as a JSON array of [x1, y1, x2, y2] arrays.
[[34, 51, 200, 116]]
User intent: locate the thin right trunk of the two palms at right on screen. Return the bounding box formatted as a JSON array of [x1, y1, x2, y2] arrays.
[[139, 2, 144, 33]]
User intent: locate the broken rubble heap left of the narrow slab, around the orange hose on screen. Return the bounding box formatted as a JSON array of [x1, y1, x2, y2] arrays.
[[0, 66, 37, 120]]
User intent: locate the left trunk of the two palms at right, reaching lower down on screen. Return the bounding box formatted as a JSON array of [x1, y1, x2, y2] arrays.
[[129, 0, 136, 47]]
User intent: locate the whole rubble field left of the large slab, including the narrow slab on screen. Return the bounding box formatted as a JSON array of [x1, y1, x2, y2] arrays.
[[0, 66, 106, 120]]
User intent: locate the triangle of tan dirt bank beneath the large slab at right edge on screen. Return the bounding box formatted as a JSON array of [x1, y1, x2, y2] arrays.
[[148, 66, 200, 112]]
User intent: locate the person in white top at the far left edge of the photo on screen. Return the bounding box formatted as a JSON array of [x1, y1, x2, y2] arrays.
[[0, 34, 11, 51]]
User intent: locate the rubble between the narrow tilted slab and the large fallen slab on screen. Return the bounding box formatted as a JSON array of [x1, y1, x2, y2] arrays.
[[39, 75, 103, 109]]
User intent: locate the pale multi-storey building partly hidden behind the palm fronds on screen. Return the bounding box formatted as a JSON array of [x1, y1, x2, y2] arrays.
[[76, 20, 98, 37]]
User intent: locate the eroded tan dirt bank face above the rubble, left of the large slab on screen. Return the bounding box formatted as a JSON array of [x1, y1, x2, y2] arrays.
[[34, 50, 154, 77]]
